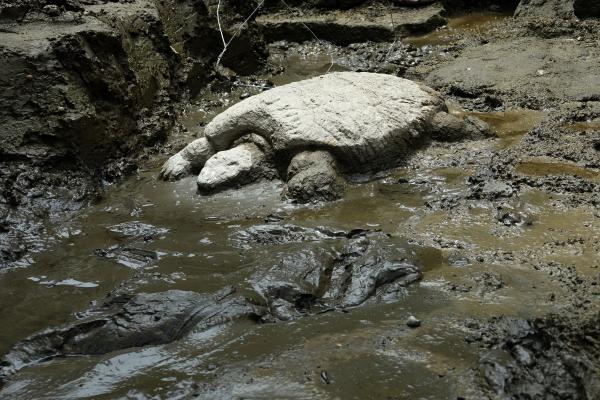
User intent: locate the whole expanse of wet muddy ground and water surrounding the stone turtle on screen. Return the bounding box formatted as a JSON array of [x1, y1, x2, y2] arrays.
[[0, 1, 600, 399]]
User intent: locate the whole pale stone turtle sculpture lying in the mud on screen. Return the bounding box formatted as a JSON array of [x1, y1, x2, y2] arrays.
[[160, 72, 488, 202]]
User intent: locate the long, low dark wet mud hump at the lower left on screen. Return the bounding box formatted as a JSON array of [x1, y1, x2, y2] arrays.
[[0, 288, 262, 382]]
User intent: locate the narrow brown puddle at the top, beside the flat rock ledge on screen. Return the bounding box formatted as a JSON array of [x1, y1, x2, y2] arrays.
[[402, 12, 512, 47]]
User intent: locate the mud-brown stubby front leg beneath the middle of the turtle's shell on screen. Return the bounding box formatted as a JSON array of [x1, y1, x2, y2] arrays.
[[284, 151, 346, 203]]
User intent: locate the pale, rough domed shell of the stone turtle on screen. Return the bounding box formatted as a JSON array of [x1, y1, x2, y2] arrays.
[[205, 72, 445, 168]]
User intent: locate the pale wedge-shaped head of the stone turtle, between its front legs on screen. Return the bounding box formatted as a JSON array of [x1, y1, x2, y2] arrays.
[[198, 143, 277, 194]]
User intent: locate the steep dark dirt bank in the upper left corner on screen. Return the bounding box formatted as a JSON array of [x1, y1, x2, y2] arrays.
[[0, 0, 270, 269]]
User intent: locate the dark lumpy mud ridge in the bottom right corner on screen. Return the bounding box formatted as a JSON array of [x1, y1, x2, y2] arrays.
[[468, 313, 600, 399]]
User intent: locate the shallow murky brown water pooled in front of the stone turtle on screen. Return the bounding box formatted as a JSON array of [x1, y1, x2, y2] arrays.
[[0, 28, 600, 399]]
